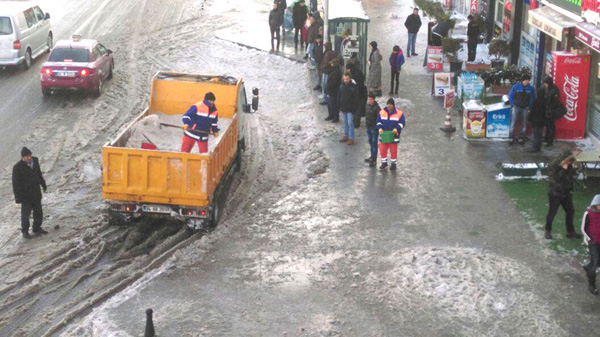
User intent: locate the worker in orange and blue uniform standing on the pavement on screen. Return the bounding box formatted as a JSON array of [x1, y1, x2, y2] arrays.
[[377, 98, 405, 171]]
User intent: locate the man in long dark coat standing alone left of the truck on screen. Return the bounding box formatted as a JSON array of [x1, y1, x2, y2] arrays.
[[12, 147, 48, 239]]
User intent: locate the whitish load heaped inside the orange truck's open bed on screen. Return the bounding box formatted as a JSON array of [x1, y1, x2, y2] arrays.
[[126, 113, 231, 152]]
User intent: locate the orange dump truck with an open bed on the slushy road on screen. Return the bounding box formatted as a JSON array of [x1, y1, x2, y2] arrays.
[[102, 72, 258, 228]]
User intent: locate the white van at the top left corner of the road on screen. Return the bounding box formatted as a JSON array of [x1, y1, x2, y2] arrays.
[[0, 1, 52, 69]]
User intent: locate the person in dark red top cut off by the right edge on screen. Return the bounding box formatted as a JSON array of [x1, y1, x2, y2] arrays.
[[581, 194, 600, 295]]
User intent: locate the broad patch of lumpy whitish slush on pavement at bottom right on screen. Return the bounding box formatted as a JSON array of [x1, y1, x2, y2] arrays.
[[386, 247, 564, 336]]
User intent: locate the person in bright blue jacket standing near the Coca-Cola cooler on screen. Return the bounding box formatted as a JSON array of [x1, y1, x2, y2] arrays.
[[508, 75, 535, 145]]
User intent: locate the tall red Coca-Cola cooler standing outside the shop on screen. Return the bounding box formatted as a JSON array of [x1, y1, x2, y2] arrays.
[[552, 52, 590, 139]]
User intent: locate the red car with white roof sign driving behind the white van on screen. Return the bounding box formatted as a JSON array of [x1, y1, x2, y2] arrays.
[[41, 35, 115, 97]]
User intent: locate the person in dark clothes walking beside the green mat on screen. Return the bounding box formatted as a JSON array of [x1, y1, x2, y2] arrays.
[[544, 150, 581, 240]]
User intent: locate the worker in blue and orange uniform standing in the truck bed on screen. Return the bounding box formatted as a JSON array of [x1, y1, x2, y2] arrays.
[[181, 92, 219, 153]]
